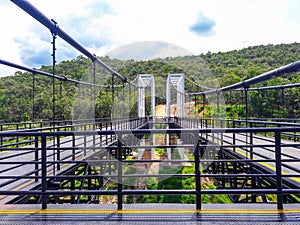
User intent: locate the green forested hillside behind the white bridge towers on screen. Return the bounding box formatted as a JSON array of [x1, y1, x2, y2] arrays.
[[0, 43, 300, 122]]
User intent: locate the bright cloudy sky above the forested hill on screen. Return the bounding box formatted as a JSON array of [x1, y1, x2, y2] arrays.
[[0, 0, 300, 76]]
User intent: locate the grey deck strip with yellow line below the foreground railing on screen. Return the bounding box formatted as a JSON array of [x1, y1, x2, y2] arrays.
[[0, 204, 300, 225]]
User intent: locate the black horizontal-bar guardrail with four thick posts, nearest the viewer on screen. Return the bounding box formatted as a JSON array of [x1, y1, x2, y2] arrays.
[[0, 125, 300, 209]]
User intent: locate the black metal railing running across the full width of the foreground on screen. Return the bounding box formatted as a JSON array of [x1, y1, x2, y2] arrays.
[[0, 125, 300, 209]]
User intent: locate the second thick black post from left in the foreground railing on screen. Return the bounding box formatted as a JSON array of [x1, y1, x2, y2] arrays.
[[117, 134, 123, 210]]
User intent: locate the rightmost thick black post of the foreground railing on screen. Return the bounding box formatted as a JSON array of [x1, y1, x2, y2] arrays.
[[275, 130, 283, 210]]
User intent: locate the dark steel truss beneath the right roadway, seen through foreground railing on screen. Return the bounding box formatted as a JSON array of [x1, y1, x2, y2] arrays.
[[204, 148, 298, 203]]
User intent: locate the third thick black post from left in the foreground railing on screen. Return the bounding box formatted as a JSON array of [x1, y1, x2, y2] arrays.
[[194, 133, 201, 210]]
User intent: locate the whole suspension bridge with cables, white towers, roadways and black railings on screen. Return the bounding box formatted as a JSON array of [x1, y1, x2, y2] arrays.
[[0, 0, 300, 224]]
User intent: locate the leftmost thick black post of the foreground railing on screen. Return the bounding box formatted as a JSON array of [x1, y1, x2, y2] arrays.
[[41, 135, 48, 209]]
